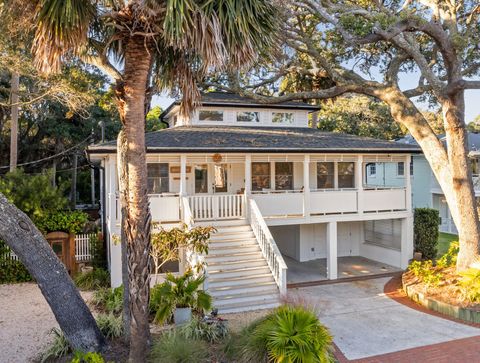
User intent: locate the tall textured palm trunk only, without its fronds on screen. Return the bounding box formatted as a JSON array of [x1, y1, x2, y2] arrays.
[[120, 36, 152, 363]]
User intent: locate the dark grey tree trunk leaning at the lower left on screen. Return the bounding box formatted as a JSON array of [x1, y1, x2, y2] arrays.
[[0, 194, 106, 352]]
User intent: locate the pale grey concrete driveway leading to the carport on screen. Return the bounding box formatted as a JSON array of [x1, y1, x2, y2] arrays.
[[289, 278, 480, 360]]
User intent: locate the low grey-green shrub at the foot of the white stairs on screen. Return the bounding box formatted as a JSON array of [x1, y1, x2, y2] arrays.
[[179, 317, 229, 343]]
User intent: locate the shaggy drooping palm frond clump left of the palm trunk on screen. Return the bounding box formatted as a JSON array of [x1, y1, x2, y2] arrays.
[[33, 0, 97, 72]]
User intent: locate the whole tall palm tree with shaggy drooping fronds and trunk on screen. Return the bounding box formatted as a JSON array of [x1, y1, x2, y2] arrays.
[[26, 0, 279, 362]]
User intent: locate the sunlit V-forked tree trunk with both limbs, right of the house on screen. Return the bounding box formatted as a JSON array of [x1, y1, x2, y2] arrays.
[[375, 88, 480, 271]]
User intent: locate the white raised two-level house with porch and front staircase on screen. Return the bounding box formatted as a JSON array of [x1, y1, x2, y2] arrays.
[[88, 92, 420, 312]]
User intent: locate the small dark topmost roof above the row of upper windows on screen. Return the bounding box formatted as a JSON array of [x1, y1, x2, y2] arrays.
[[160, 92, 320, 118]]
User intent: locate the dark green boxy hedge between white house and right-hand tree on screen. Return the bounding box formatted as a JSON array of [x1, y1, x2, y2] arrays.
[[413, 208, 440, 260]]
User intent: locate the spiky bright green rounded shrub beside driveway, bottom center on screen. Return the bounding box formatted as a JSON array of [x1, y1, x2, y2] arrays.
[[234, 305, 333, 363]]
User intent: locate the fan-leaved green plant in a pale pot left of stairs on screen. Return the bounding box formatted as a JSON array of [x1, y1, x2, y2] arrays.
[[150, 270, 212, 324]]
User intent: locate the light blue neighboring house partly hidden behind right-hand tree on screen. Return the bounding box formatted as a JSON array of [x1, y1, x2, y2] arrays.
[[394, 132, 480, 234]]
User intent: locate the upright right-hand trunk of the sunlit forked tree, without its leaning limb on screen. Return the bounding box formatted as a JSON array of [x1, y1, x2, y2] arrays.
[[442, 91, 480, 271]]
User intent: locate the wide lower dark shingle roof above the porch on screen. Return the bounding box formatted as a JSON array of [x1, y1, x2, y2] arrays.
[[89, 126, 421, 153]]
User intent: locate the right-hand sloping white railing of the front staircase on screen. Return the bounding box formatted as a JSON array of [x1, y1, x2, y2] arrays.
[[249, 199, 287, 294]]
